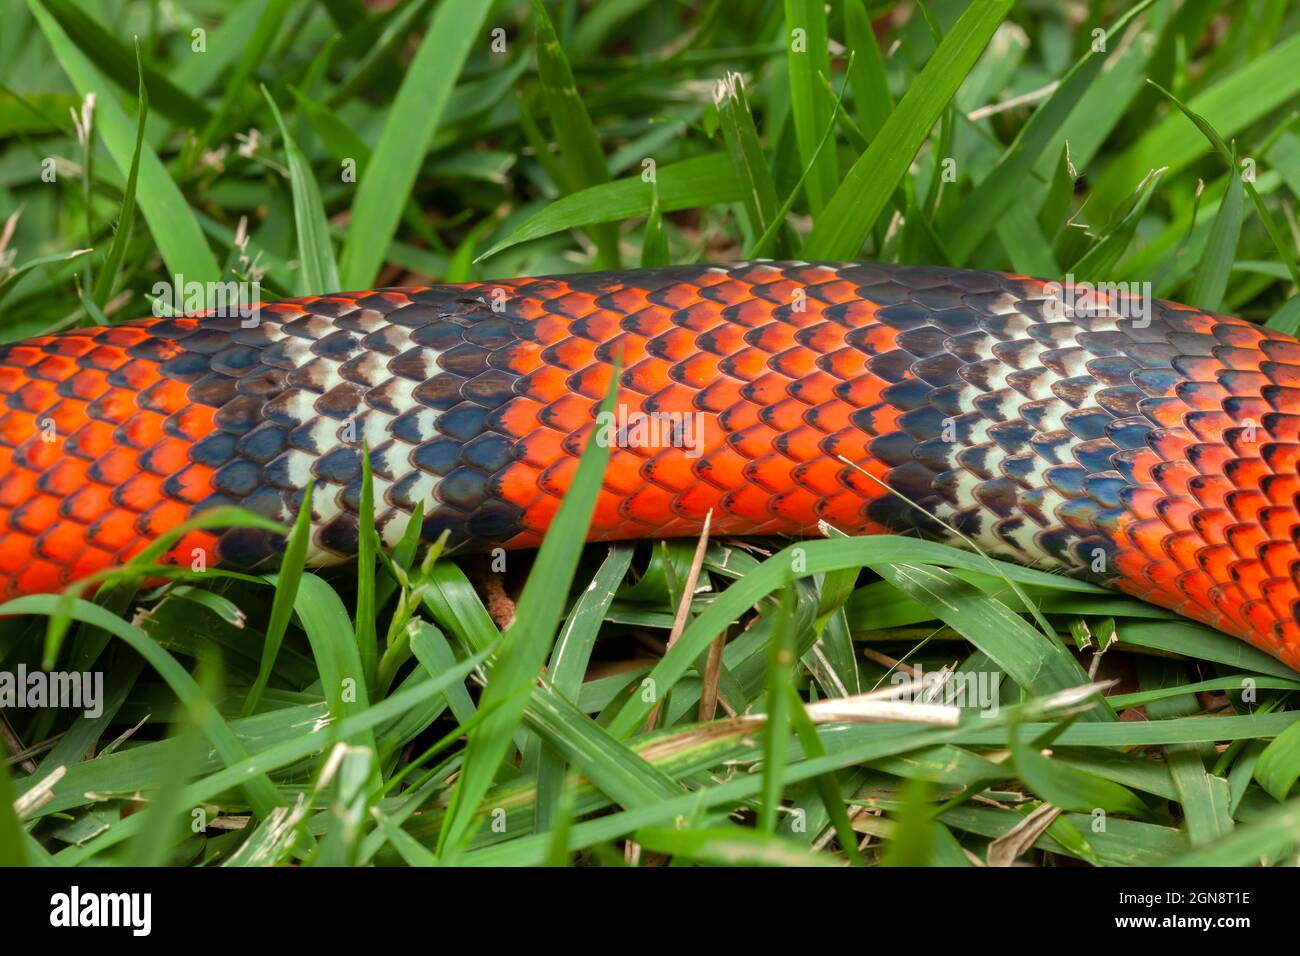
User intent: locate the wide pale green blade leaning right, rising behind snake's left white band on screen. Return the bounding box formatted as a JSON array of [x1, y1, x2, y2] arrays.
[[339, 0, 491, 289]]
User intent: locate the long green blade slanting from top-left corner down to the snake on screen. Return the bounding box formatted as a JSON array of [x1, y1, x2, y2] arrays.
[[27, 0, 221, 282]]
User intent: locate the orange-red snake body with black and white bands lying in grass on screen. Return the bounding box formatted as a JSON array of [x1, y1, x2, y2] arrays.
[[0, 260, 1300, 670]]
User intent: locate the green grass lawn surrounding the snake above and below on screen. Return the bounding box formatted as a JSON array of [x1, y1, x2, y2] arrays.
[[0, 0, 1300, 866]]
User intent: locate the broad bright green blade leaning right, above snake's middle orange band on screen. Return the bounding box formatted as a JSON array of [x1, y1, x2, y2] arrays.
[[802, 0, 1011, 260]]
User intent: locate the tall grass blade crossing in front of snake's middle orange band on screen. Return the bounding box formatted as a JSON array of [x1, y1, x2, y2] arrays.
[[438, 359, 621, 856]]
